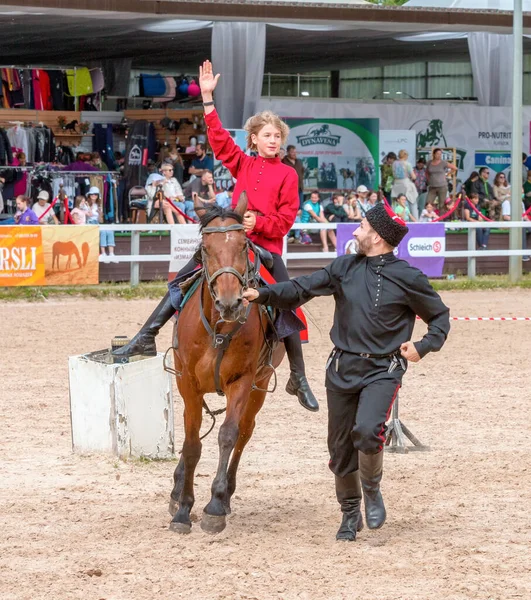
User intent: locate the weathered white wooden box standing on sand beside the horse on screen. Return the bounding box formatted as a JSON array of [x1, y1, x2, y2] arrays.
[[68, 353, 174, 459]]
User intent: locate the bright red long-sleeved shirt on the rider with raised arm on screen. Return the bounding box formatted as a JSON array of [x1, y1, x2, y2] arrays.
[[205, 111, 299, 254]]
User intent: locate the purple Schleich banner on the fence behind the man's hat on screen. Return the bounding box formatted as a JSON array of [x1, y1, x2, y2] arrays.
[[337, 223, 446, 277]]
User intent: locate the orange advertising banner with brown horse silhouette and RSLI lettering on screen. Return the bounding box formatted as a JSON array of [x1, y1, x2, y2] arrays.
[[0, 225, 100, 286]]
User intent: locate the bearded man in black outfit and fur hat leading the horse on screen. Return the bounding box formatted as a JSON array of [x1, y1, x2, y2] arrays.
[[244, 204, 450, 541]]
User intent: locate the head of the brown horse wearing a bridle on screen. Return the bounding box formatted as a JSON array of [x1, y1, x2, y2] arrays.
[[196, 192, 249, 321]]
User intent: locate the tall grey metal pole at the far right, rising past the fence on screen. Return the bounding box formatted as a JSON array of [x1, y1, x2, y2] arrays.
[[509, 0, 523, 283]]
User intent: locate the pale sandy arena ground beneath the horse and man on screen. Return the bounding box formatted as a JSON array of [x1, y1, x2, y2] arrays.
[[0, 290, 531, 600]]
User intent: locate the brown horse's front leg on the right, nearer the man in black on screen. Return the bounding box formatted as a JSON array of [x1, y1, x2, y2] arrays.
[[201, 377, 252, 533]]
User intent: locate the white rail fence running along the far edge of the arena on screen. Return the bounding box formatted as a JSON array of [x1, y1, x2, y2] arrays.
[[100, 221, 531, 285]]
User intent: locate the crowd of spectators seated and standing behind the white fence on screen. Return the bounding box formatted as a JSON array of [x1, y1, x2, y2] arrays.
[[0, 143, 531, 262]]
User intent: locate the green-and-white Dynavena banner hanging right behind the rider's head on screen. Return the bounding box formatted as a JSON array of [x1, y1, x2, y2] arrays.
[[285, 118, 379, 191]]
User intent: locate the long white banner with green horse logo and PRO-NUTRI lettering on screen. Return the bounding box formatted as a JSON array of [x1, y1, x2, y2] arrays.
[[258, 98, 531, 181]]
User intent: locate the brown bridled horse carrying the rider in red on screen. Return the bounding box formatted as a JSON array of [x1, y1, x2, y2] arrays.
[[169, 193, 284, 533]]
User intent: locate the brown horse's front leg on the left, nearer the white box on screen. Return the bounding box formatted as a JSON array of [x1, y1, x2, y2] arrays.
[[170, 375, 203, 533]]
